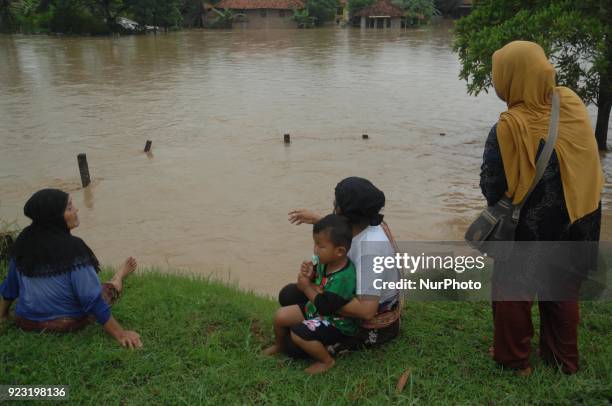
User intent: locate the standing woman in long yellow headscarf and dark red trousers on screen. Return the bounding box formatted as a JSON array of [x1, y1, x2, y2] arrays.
[[480, 41, 603, 375]]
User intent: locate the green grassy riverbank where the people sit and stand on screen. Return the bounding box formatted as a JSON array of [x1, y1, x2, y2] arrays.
[[0, 269, 612, 404]]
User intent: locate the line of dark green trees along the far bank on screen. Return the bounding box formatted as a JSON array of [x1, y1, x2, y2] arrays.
[[0, 0, 461, 35]]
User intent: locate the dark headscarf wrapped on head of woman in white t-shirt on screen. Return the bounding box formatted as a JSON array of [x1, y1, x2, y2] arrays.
[[336, 177, 385, 226]]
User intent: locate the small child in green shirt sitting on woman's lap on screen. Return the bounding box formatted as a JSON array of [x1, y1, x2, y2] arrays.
[[264, 214, 360, 374]]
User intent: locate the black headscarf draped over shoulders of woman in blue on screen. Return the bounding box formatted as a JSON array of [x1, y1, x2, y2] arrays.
[[12, 189, 99, 277]]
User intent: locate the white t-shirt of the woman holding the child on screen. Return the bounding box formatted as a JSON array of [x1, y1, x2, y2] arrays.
[[348, 225, 399, 303]]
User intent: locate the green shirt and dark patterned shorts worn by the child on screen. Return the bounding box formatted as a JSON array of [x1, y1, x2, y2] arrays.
[[304, 258, 361, 336]]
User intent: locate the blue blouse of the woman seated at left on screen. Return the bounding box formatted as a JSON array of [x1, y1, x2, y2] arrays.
[[0, 260, 111, 324]]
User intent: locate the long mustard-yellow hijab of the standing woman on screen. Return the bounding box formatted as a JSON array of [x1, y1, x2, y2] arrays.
[[493, 41, 603, 223]]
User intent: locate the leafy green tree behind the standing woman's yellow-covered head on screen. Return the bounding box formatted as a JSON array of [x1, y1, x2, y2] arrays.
[[454, 0, 612, 150]]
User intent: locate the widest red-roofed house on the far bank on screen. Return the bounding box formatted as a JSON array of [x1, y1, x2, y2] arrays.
[[216, 0, 304, 28]]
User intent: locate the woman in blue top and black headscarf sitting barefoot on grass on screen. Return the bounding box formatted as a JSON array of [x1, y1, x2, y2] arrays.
[[0, 189, 142, 348]]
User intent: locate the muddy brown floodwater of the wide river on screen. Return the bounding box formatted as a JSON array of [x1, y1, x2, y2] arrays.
[[0, 25, 612, 294]]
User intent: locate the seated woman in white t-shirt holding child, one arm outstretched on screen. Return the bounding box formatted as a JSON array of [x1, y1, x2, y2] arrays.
[[279, 177, 400, 357]]
